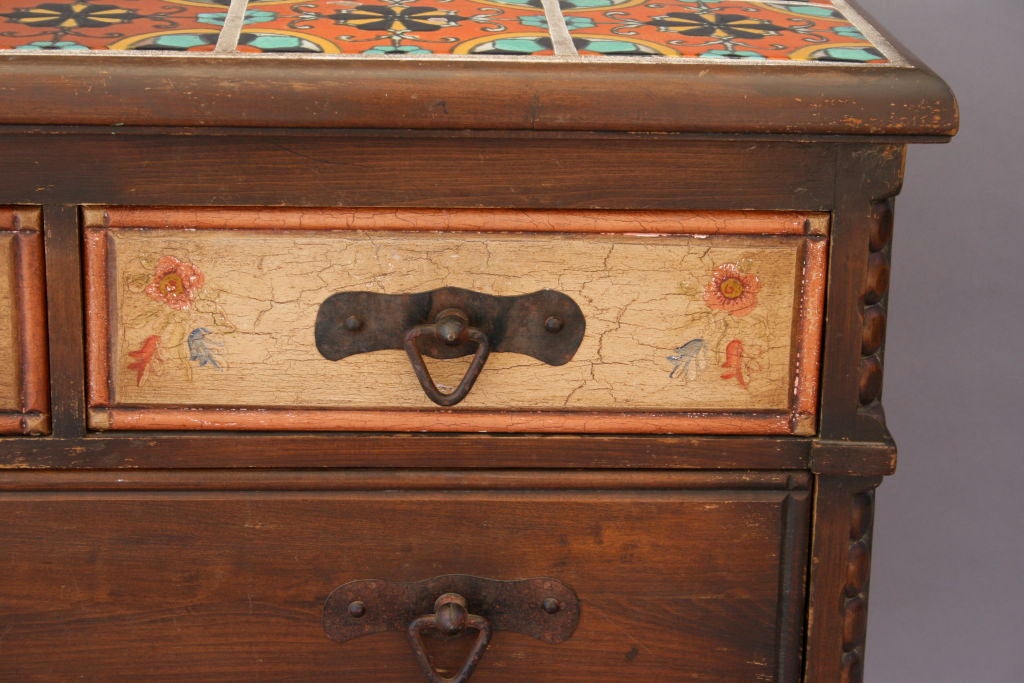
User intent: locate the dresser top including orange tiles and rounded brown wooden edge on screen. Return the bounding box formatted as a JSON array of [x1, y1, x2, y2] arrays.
[[0, 0, 956, 137]]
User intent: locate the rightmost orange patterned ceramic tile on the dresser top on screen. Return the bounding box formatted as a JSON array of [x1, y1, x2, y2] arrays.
[[562, 0, 888, 63]]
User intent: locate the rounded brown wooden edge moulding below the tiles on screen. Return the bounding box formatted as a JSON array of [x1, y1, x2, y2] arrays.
[[0, 54, 956, 136]]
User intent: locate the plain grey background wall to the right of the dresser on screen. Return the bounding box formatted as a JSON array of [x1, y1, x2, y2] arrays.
[[859, 0, 1024, 683]]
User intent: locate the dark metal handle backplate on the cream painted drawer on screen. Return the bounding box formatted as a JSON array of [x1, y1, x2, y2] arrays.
[[315, 287, 587, 366]]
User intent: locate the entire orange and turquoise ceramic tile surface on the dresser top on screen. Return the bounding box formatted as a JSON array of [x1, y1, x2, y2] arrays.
[[0, 0, 898, 65]]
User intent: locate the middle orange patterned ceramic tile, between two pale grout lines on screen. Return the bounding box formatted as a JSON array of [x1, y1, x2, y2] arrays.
[[230, 0, 554, 56]]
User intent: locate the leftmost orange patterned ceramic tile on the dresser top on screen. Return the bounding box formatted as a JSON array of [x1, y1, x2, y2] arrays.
[[0, 0, 228, 51]]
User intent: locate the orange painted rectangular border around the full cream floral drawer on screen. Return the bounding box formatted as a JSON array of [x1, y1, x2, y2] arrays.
[[83, 207, 828, 435]]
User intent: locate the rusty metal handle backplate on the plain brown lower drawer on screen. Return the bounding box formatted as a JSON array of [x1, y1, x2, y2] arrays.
[[324, 574, 580, 644]]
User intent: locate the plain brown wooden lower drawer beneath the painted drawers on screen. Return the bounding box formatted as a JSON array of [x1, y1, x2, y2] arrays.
[[0, 473, 809, 683]]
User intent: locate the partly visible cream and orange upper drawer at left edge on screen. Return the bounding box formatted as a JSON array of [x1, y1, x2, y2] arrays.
[[0, 207, 49, 434]]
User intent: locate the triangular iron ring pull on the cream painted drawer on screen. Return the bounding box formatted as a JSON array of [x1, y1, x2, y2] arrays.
[[404, 308, 490, 407]]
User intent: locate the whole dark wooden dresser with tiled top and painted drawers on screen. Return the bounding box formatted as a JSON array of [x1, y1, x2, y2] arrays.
[[0, 0, 956, 683]]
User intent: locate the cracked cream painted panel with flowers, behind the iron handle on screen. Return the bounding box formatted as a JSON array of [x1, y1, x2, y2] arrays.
[[110, 229, 806, 412]]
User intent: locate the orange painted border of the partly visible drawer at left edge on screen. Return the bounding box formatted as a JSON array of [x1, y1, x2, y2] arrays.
[[0, 207, 50, 434]]
